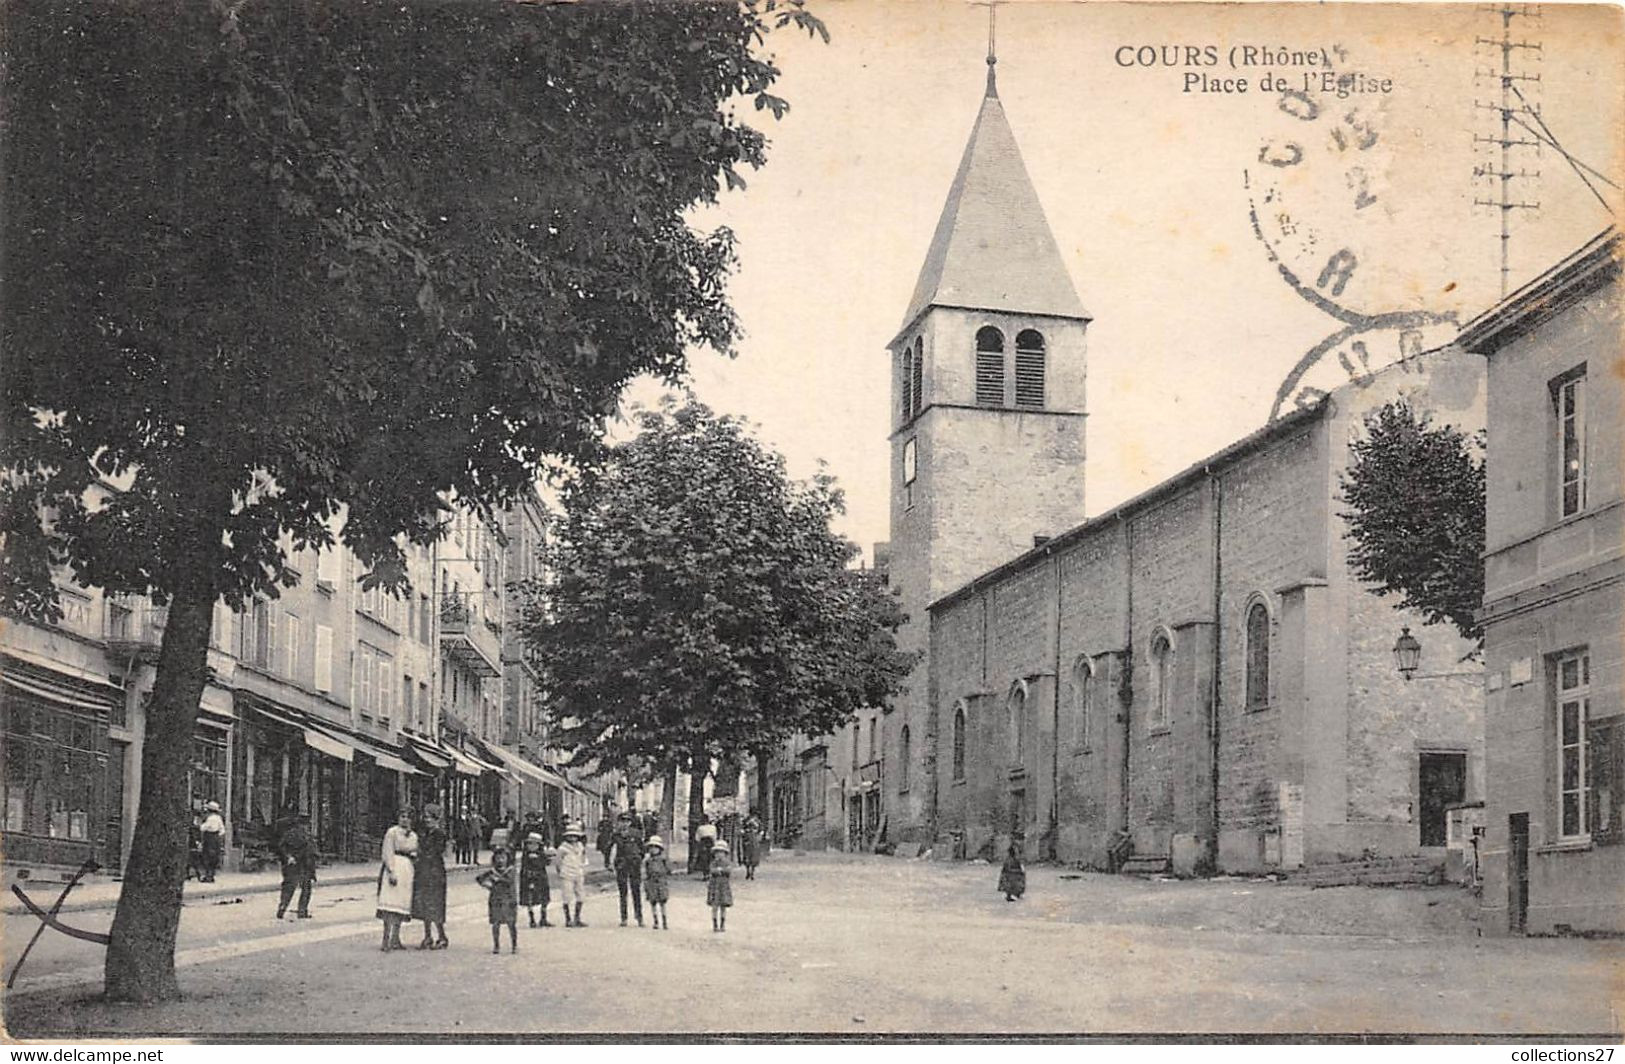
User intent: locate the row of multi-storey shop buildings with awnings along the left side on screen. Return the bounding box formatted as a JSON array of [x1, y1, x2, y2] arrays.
[[0, 497, 614, 876]]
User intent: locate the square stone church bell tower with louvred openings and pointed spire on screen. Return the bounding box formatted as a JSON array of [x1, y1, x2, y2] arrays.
[[886, 34, 1089, 845]]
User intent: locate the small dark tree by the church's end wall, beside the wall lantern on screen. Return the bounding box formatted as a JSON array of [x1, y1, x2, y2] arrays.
[[1341, 400, 1484, 640]]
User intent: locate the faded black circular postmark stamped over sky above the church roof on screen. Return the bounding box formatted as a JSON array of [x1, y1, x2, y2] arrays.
[[1243, 70, 1458, 421]]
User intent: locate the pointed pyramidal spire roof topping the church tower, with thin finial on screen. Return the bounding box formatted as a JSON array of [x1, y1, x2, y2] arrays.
[[899, 20, 1089, 341]]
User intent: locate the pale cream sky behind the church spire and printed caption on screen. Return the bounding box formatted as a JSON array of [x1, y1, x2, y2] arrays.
[[617, 0, 1625, 562]]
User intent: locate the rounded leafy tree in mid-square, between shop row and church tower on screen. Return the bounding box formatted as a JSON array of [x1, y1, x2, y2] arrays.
[[523, 400, 915, 857]]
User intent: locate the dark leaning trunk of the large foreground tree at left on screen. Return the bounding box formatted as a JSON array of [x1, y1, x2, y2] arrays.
[[104, 586, 215, 1002]]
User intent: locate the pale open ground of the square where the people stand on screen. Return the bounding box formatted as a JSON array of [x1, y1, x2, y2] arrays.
[[3, 853, 1625, 1038]]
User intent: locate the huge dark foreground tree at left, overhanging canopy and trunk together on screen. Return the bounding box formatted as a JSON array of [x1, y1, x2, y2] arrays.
[[0, 0, 822, 999]]
